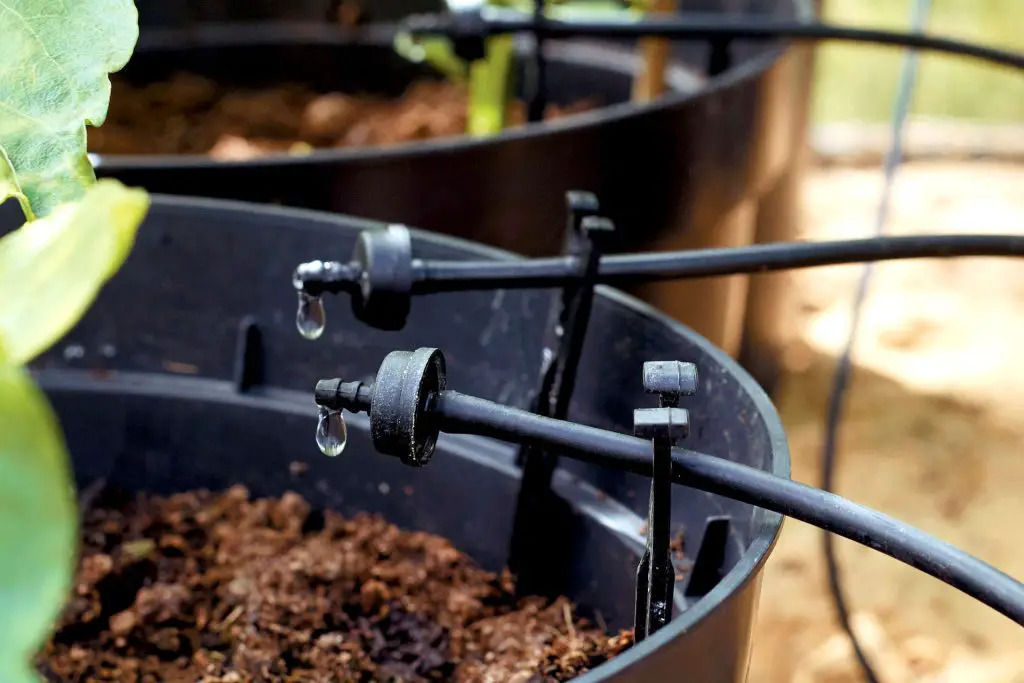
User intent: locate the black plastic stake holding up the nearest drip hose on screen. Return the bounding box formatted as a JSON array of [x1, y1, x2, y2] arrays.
[[633, 360, 697, 642]]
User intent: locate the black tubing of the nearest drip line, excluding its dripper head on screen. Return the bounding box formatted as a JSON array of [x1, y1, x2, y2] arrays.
[[428, 391, 1024, 625]]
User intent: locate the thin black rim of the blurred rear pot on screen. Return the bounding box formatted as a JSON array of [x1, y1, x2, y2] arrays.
[[89, 20, 782, 173]]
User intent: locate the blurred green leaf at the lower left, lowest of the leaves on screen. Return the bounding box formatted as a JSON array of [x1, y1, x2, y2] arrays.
[[0, 365, 78, 683]]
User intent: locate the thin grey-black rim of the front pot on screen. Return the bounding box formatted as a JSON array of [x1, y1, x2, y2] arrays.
[[130, 194, 791, 683]]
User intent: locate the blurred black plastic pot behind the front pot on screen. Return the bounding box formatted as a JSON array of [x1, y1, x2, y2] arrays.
[[97, 0, 806, 379]]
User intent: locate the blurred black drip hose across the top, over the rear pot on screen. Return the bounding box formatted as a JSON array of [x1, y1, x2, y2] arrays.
[[403, 13, 1024, 70]]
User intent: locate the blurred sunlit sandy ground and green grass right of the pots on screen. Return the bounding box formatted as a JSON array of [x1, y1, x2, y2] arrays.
[[750, 0, 1024, 683]]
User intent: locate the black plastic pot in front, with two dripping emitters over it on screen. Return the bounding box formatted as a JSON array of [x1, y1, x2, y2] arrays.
[[7, 198, 788, 683]]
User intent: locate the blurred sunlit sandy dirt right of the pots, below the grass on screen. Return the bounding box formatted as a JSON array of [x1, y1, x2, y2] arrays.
[[750, 162, 1024, 683]]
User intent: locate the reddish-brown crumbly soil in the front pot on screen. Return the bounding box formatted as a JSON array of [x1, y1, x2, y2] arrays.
[[46, 486, 632, 683]]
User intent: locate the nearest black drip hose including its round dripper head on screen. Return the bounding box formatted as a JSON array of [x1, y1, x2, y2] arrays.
[[315, 376, 1024, 625]]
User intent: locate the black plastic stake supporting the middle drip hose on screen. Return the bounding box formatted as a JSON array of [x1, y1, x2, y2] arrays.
[[509, 191, 613, 595]]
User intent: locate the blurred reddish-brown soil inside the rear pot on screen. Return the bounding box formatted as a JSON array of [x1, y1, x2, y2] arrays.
[[88, 74, 597, 160]]
